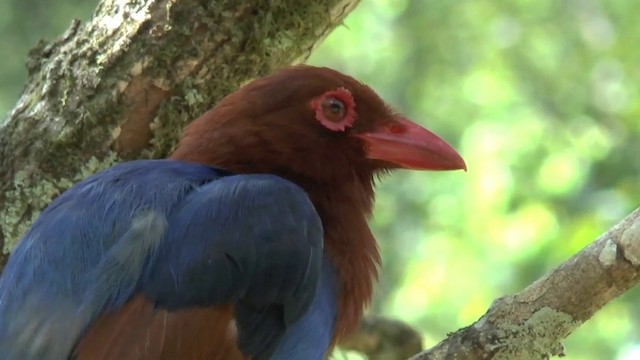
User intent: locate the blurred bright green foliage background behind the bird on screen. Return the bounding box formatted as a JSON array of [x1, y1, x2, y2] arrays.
[[0, 0, 640, 360]]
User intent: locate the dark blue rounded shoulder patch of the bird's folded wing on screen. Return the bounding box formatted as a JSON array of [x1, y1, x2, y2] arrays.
[[141, 175, 323, 359]]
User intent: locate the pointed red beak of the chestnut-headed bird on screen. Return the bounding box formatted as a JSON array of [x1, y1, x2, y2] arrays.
[[355, 117, 467, 171]]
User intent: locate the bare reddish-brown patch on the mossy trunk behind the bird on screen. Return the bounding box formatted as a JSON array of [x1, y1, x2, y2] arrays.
[[111, 76, 170, 158]]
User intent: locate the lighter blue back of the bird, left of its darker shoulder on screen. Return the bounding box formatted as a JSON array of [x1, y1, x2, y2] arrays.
[[0, 160, 226, 360]]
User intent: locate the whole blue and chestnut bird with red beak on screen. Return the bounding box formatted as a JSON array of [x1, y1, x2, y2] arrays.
[[0, 65, 466, 360]]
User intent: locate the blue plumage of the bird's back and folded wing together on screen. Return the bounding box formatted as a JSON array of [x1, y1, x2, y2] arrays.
[[0, 160, 328, 360]]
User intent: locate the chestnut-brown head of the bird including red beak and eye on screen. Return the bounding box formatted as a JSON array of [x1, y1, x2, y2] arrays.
[[173, 66, 466, 191]]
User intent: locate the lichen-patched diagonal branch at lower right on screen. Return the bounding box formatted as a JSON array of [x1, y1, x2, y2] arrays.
[[411, 209, 640, 360]]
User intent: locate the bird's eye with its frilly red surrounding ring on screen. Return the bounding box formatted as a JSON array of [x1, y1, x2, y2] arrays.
[[311, 88, 357, 131]]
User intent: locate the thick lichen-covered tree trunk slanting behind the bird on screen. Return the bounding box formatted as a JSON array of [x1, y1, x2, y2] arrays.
[[0, 0, 359, 269]]
